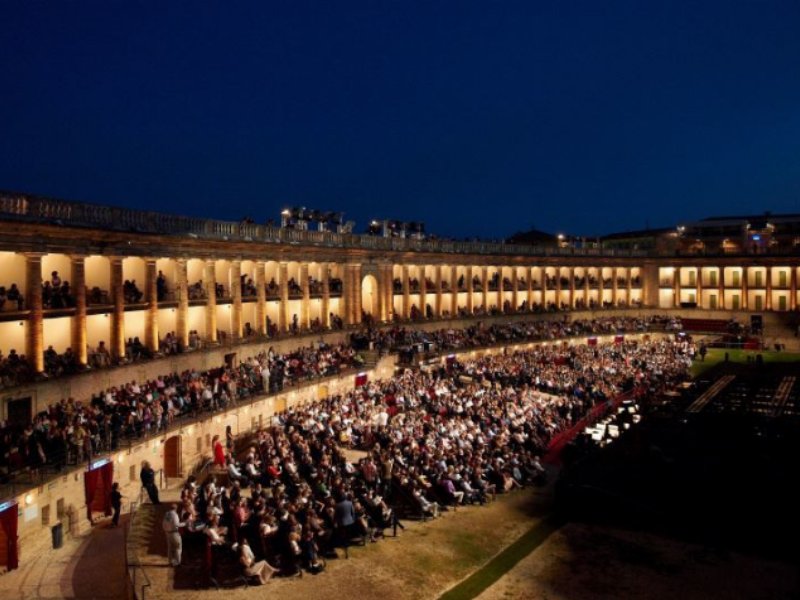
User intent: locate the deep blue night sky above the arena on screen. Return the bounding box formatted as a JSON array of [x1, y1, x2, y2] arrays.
[[0, 0, 800, 237]]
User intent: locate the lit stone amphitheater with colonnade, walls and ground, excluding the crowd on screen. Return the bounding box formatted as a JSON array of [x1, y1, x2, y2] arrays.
[[0, 193, 800, 599]]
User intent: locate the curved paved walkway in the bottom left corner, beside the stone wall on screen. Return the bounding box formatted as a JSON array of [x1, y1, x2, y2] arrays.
[[0, 515, 127, 600]]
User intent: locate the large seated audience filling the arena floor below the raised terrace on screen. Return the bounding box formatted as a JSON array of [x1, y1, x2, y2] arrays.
[[181, 341, 691, 575]]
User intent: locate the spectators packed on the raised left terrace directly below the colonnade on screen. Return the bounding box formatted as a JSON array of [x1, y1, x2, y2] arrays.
[[0, 344, 363, 475]]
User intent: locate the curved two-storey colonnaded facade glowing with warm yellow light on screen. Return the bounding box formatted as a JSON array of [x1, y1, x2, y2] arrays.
[[0, 194, 800, 380]]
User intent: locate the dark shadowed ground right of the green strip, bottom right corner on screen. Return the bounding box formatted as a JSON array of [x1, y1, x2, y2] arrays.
[[478, 524, 799, 600]]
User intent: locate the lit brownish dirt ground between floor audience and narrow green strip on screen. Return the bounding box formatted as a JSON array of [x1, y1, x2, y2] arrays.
[[131, 490, 549, 600]]
